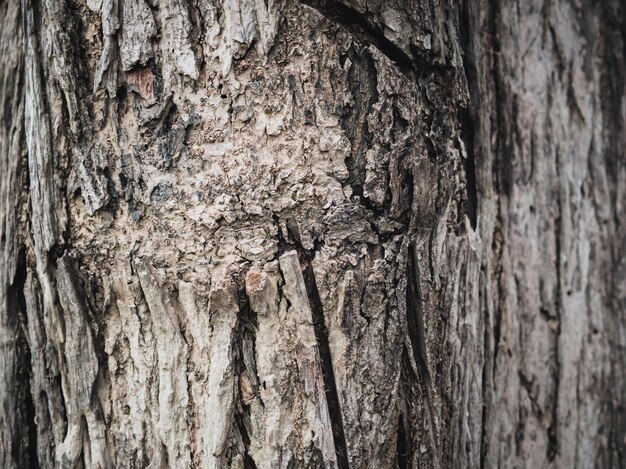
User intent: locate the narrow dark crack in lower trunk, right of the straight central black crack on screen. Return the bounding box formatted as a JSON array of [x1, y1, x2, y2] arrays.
[[406, 244, 439, 466]]
